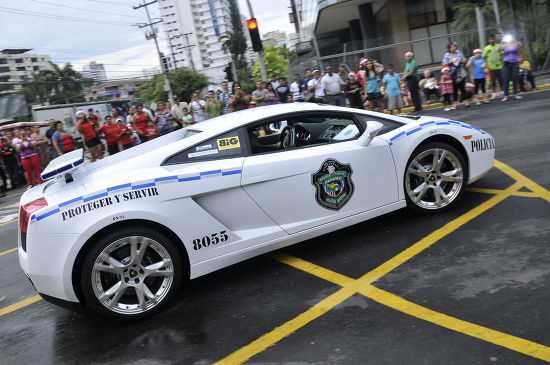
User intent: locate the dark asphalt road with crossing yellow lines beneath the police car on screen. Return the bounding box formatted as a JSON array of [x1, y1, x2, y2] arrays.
[[0, 91, 550, 365]]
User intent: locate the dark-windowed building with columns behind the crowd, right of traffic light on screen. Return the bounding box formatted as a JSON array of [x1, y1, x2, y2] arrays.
[[289, 0, 453, 69]]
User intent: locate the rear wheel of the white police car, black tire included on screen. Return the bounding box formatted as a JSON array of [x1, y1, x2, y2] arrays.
[[80, 226, 186, 321]]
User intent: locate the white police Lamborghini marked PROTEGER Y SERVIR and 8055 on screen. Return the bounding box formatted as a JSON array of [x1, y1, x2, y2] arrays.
[[19, 103, 494, 319]]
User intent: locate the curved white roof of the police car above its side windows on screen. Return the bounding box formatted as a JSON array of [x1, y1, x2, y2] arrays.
[[189, 103, 366, 132]]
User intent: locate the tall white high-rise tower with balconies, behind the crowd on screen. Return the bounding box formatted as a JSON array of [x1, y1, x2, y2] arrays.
[[158, 0, 236, 84]]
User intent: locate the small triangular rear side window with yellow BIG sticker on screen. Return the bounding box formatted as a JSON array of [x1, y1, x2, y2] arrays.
[[164, 130, 246, 165]]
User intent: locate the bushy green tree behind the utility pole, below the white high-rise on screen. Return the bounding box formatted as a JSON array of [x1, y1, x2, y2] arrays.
[[137, 67, 208, 103]]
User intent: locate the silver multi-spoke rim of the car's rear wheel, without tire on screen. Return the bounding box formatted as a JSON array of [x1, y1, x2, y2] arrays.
[[91, 236, 174, 315]]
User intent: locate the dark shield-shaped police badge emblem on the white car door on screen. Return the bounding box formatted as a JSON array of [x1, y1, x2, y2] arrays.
[[311, 159, 354, 210]]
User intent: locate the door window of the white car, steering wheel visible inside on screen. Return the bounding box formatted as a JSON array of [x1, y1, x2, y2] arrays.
[[247, 113, 361, 154]]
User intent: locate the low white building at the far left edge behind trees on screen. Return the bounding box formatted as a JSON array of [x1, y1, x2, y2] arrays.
[[0, 49, 52, 95]]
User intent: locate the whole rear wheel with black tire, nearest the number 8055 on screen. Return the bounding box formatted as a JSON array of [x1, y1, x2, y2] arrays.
[[82, 228, 181, 320]]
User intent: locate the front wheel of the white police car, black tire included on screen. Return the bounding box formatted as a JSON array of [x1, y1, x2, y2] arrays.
[[403, 142, 468, 214]]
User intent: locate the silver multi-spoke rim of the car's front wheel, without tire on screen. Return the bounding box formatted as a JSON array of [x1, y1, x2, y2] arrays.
[[405, 148, 464, 209]]
